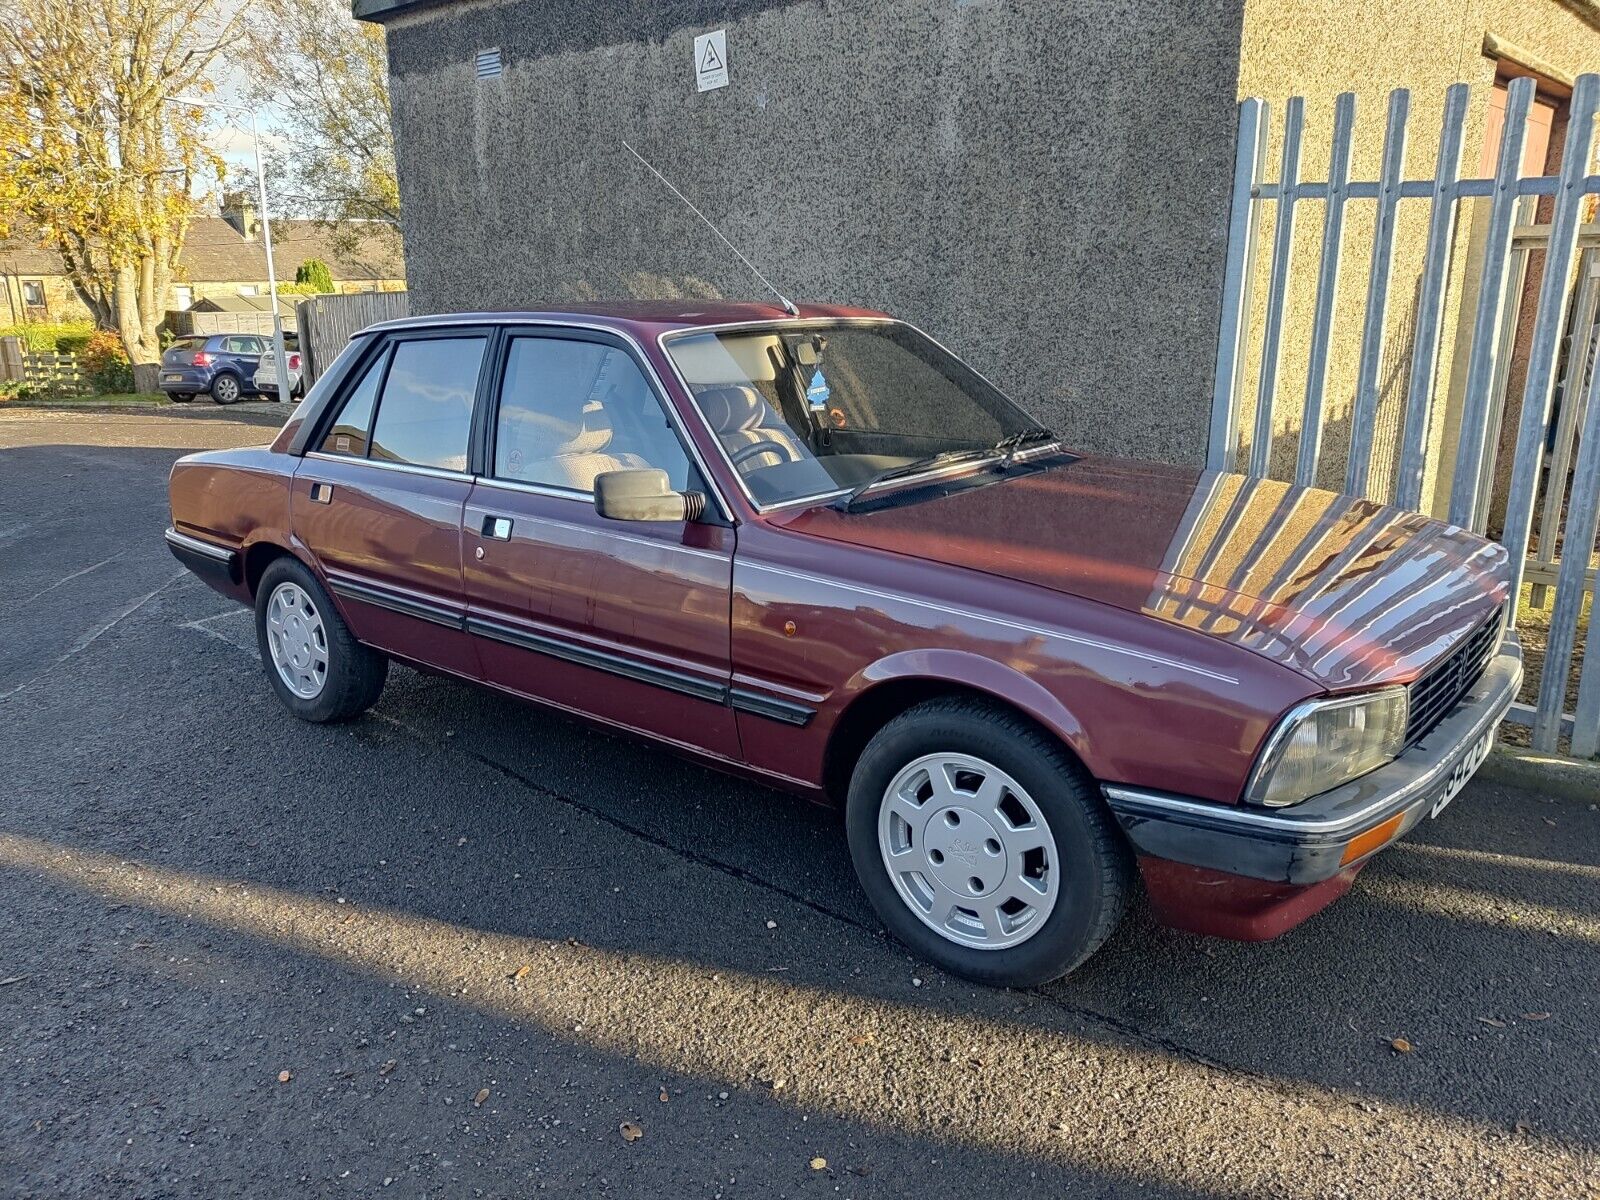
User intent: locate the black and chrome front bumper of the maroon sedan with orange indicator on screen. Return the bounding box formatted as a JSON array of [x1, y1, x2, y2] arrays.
[[1104, 635, 1522, 888]]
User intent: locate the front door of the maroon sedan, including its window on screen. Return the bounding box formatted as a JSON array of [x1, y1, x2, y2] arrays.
[[462, 326, 738, 758]]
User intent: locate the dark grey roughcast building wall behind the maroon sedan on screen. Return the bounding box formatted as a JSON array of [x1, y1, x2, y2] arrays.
[[377, 0, 1243, 462]]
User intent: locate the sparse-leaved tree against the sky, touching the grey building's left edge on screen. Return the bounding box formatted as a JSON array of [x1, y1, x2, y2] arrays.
[[250, 0, 400, 248]]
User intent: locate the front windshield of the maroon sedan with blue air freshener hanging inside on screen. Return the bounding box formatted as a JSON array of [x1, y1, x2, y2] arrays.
[[664, 322, 1040, 506]]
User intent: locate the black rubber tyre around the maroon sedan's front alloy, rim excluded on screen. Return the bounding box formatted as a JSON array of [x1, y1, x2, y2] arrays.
[[845, 698, 1134, 987]]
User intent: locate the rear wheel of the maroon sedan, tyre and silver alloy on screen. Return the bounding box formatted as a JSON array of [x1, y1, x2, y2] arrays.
[[256, 557, 389, 723]]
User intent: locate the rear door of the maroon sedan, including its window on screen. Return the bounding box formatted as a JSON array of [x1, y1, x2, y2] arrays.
[[290, 326, 493, 677]]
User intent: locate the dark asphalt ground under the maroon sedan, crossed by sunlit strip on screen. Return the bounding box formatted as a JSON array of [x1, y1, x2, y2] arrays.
[[0, 405, 1600, 1198]]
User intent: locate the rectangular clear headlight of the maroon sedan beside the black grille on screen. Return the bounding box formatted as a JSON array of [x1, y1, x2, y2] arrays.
[[1245, 688, 1410, 808]]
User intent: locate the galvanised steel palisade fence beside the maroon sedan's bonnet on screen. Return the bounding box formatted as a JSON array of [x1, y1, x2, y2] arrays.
[[1206, 74, 1600, 757]]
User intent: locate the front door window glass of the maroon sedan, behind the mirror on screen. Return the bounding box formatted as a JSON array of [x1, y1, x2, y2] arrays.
[[494, 338, 690, 491]]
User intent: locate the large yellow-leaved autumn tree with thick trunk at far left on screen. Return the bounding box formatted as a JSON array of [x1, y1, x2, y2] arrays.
[[0, 0, 243, 363]]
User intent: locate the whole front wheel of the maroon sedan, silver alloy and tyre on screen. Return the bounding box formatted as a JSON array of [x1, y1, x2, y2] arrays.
[[845, 699, 1133, 987]]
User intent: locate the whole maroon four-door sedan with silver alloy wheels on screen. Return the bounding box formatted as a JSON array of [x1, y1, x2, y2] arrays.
[[166, 304, 1522, 984]]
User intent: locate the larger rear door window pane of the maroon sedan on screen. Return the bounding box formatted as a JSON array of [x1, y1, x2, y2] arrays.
[[368, 338, 483, 470]]
